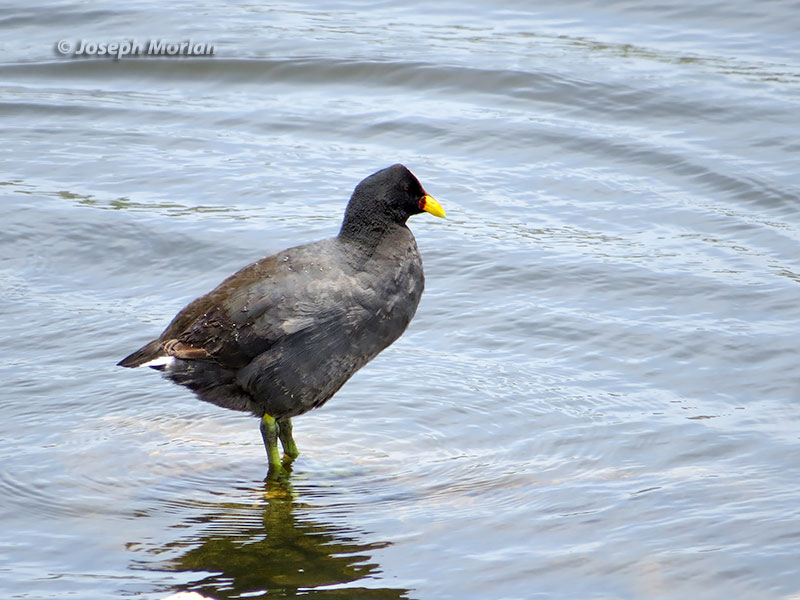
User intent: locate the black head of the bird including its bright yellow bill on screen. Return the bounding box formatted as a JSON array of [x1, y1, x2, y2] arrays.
[[339, 164, 444, 244]]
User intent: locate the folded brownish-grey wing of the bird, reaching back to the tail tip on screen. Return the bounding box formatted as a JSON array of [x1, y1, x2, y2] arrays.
[[119, 240, 360, 369]]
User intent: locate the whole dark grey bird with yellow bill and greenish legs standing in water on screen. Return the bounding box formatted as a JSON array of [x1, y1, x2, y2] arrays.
[[117, 164, 445, 479]]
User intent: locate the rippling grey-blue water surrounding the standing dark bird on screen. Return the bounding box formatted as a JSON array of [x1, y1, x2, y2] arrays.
[[0, 0, 800, 600]]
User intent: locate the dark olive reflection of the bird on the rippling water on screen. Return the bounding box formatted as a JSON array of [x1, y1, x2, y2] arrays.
[[135, 482, 410, 600]]
